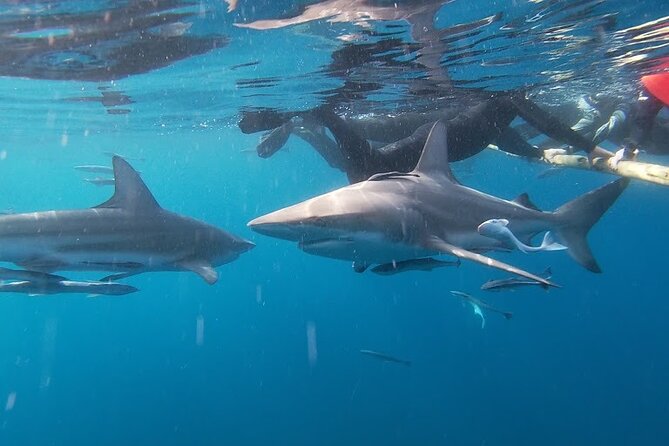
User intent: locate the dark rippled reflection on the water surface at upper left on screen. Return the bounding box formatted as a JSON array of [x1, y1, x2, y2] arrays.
[[0, 0, 228, 81]]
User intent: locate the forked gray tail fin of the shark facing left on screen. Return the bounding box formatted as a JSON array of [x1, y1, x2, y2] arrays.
[[555, 178, 629, 273]]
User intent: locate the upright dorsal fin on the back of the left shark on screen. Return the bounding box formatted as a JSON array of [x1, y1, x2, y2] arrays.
[[96, 156, 160, 213]]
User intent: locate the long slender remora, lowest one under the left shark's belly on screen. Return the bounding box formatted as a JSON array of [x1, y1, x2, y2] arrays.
[[0, 280, 139, 296]]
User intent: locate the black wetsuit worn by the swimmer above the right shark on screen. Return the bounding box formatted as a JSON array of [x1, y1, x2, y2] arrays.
[[312, 94, 595, 182]]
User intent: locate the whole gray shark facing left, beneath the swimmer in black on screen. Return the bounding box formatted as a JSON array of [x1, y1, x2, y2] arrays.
[[248, 122, 627, 286]]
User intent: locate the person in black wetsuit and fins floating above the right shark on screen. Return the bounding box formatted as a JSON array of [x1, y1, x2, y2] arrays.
[[240, 93, 612, 183]]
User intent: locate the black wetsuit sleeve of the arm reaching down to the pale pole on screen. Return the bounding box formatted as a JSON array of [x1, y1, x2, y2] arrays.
[[511, 95, 596, 153]]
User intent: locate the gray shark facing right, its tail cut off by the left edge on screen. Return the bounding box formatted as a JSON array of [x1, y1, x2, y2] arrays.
[[0, 156, 254, 284]]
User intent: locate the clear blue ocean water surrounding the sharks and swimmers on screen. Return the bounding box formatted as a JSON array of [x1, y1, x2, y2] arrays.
[[0, 1, 669, 446]]
